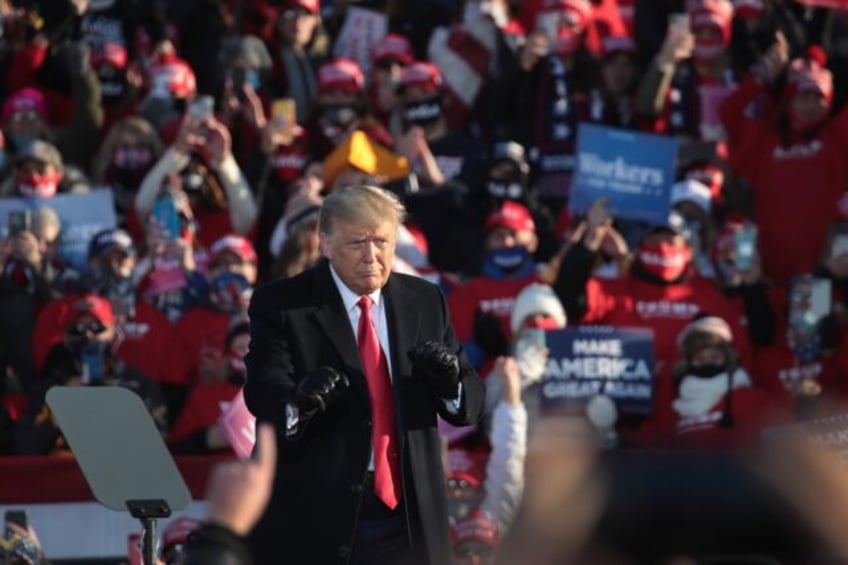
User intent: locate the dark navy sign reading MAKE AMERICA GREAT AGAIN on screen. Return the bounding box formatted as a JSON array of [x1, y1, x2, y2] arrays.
[[541, 326, 654, 414]]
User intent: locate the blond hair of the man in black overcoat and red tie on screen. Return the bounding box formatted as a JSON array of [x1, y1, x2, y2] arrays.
[[318, 185, 406, 235]]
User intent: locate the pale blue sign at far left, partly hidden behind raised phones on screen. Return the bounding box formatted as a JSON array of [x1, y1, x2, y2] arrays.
[[0, 189, 118, 271]]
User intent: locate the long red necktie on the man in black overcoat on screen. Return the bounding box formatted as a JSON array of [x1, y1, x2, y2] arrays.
[[357, 296, 400, 509]]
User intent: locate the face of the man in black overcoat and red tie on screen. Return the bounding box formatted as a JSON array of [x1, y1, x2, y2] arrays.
[[320, 216, 397, 295]]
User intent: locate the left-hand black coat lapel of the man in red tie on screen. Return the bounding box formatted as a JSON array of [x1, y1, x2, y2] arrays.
[[314, 262, 368, 399]]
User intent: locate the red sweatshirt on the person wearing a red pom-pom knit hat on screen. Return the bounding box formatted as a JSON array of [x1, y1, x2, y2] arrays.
[[720, 79, 848, 281]]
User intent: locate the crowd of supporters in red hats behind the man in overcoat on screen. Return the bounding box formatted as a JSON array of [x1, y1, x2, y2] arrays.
[[0, 0, 848, 563]]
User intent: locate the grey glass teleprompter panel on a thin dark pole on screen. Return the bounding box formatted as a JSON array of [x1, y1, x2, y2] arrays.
[[47, 386, 191, 565]]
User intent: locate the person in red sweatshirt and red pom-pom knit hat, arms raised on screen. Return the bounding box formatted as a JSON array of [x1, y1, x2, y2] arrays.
[[721, 35, 848, 284]]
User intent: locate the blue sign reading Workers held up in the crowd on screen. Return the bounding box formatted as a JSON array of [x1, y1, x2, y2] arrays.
[[568, 123, 677, 224]]
